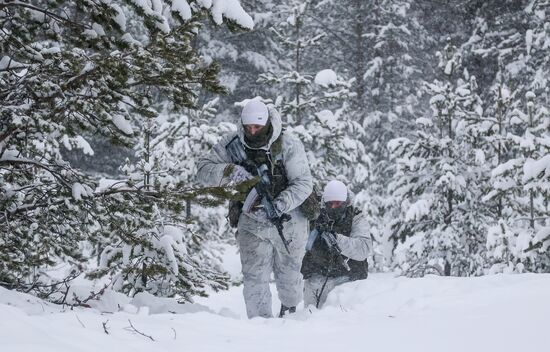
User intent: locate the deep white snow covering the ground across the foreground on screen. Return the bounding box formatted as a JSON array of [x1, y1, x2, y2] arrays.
[[0, 246, 550, 352]]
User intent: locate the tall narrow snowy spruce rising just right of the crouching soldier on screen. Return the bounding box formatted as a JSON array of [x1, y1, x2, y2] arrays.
[[360, 0, 433, 270]]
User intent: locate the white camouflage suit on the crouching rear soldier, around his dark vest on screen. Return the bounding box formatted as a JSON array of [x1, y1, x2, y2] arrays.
[[304, 192, 372, 308]]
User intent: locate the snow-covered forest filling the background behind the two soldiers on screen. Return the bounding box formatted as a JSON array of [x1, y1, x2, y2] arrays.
[[0, 0, 550, 303]]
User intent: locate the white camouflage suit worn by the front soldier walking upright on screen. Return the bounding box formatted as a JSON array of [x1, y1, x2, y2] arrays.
[[197, 108, 313, 318]]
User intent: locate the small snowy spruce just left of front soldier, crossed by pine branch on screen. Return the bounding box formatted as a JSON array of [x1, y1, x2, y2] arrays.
[[91, 99, 239, 301]]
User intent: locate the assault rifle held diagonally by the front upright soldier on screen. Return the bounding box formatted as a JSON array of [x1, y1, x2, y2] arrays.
[[225, 136, 290, 254]]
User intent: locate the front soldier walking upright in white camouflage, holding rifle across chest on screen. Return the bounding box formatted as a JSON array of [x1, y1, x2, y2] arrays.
[[197, 100, 313, 318]]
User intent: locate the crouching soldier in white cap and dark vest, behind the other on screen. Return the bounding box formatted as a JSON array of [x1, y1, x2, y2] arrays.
[[302, 181, 372, 308]]
